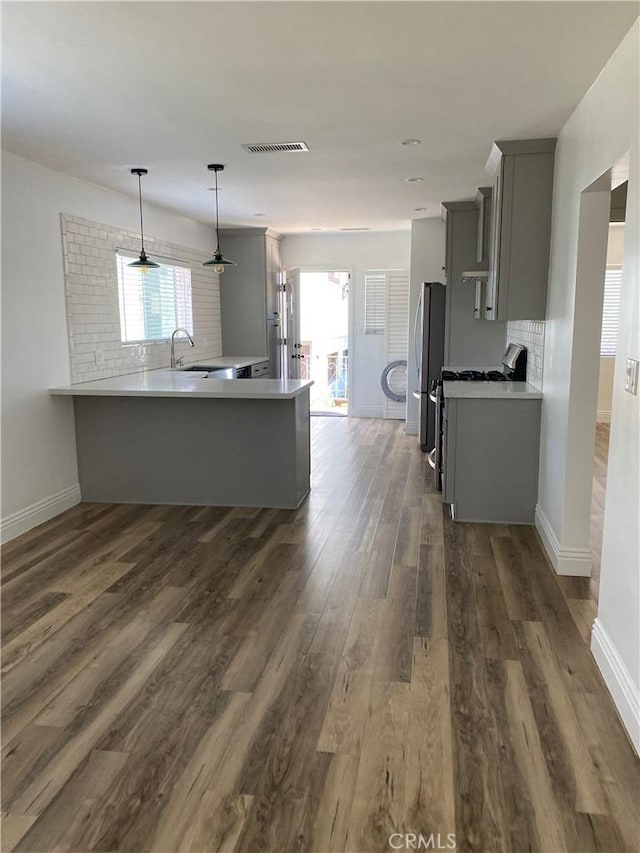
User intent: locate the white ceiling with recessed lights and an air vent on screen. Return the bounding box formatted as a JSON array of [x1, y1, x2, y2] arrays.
[[2, 0, 638, 233]]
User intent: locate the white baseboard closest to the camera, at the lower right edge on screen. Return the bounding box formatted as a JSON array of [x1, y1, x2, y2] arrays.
[[591, 619, 640, 754]]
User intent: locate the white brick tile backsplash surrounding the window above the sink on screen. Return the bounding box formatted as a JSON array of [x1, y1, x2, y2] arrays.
[[60, 213, 222, 383]]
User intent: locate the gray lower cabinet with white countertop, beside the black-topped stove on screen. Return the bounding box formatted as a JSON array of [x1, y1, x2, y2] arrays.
[[442, 398, 542, 524]]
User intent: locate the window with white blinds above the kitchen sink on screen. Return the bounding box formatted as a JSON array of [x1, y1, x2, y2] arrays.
[[116, 252, 193, 344]]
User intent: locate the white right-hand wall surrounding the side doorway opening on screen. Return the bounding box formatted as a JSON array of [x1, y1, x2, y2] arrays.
[[537, 22, 640, 747]]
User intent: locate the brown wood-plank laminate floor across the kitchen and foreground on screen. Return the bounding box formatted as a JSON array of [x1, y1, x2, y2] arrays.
[[2, 418, 639, 853]]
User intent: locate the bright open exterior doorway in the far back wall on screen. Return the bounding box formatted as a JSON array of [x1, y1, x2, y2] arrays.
[[299, 270, 351, 417]]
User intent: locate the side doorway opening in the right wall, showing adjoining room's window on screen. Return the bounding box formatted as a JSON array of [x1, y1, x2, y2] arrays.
[[558, 155, 629, 644]]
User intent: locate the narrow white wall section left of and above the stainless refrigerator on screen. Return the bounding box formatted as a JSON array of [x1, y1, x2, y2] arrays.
[[407, 217, 446, 435]]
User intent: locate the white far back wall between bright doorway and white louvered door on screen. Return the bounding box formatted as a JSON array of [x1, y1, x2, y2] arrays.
[[280, 231, 411, 418]]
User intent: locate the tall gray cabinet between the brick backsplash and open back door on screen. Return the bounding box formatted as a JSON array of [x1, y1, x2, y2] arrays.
[[220, 228, 281, 362]]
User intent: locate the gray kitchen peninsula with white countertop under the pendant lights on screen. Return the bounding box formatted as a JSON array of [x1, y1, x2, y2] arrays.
[[50, 370, 313, 509]]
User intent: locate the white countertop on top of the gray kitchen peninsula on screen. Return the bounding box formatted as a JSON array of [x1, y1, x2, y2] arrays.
[[49, 370, 313, 400]]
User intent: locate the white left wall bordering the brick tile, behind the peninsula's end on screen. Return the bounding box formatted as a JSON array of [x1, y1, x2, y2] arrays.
[[2, 152, 213, 540]]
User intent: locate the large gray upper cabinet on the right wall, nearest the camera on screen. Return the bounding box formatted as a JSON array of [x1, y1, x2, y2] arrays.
[[484, 139, 556, 320]]
